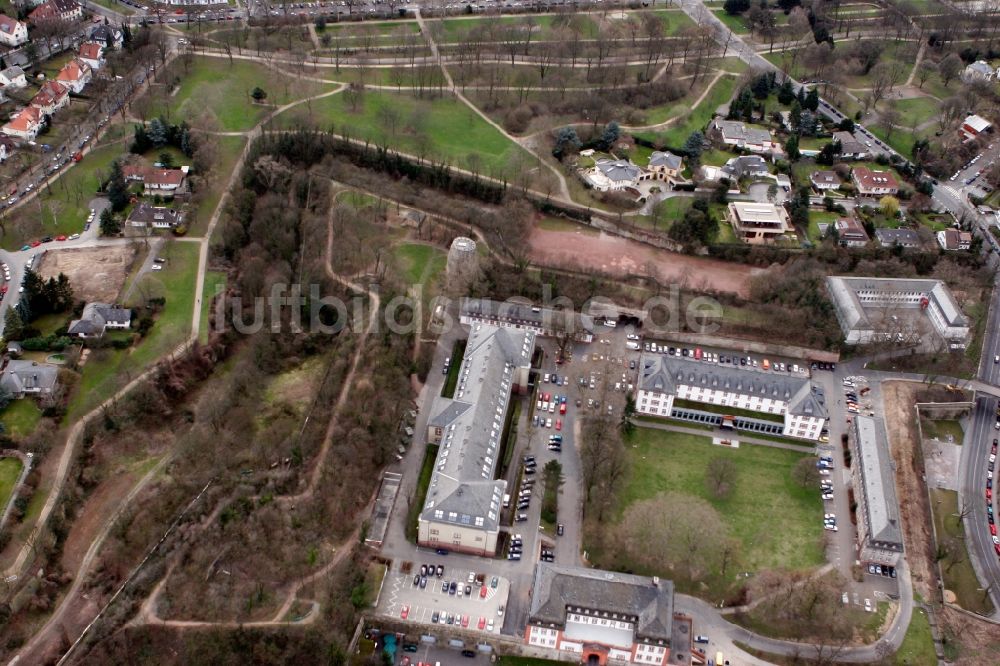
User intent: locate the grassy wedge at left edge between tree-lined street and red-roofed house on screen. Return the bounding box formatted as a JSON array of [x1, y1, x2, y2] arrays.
[[3, 145, 122, 250]]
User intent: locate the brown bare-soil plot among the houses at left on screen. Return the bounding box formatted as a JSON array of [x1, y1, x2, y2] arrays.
[[35, 243, 137, 303]]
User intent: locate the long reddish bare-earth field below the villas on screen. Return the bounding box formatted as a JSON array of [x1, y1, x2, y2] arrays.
[[530, 227, 763, 298]]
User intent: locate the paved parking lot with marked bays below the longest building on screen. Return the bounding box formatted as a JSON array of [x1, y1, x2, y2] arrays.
[[379, 560, 510, 634]]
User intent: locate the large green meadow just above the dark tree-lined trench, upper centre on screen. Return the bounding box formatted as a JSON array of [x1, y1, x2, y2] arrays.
[[277, 90, 533, 175]]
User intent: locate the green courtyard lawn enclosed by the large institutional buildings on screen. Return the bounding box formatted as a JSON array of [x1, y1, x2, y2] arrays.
[[619, 428, 824, 571]]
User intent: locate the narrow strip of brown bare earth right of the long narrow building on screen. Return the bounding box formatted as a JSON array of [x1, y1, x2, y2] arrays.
[[882, 382, 940, 601]]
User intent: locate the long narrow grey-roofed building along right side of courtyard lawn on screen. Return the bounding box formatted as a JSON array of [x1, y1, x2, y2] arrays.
[[851, 415, 903, 566]]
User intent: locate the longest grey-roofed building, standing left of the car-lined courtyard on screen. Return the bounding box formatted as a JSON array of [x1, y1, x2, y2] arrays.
[[417, 322, 535, 556]]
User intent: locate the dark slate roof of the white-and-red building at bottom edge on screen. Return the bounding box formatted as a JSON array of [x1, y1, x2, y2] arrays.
[[528, 562, 674, 644]]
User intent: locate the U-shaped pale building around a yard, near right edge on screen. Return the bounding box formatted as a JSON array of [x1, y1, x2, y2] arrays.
[[826, 275, 969, 349]]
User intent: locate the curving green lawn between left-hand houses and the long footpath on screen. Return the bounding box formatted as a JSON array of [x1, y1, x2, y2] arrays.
[[66, 241, 199, 422]]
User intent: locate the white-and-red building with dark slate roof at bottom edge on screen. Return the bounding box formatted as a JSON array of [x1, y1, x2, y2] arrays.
[[524, 562, 676, 666]]
